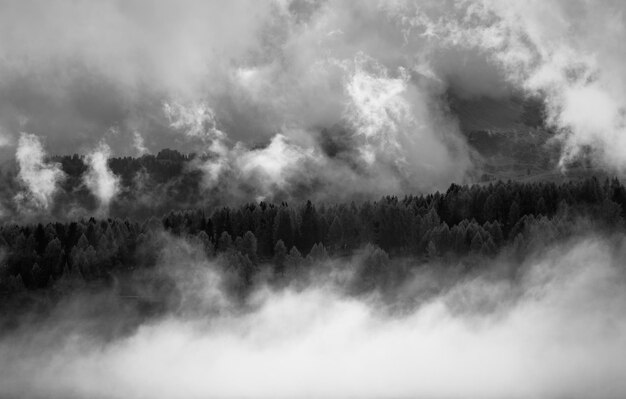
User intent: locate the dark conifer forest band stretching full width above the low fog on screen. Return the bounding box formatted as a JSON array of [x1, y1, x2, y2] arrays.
[[0, 178, 626, 292]]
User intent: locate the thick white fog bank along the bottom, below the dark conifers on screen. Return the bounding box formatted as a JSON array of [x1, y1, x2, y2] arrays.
[[0, 236, 626, 398]]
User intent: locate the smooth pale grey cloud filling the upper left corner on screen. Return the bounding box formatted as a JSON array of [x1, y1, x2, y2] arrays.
[[0, 0, 274, 152]]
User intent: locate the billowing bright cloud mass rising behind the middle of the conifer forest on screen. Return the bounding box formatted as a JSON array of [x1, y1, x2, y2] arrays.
[[164, 53, 471, 200]]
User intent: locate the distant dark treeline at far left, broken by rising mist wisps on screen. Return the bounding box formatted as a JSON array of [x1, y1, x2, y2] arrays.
[[0, 149, 205, 220]]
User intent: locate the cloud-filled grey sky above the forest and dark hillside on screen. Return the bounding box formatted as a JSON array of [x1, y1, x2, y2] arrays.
[[0, 0, 626, 198]]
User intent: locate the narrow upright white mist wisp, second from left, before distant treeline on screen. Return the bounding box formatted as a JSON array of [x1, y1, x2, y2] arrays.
[[83, 142, 120, 214]]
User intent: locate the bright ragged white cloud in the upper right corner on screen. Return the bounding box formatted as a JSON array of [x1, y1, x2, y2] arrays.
[[400, 1, 626, 172]]
